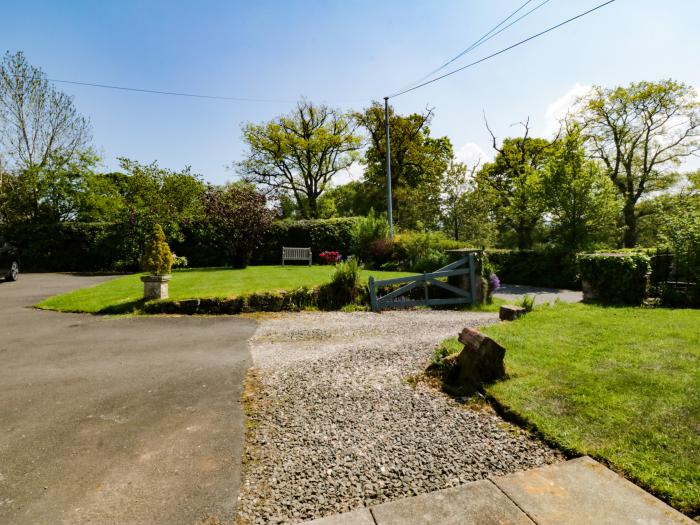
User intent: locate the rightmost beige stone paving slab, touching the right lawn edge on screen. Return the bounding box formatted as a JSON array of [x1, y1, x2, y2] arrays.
[[491, 456, 697, 525]]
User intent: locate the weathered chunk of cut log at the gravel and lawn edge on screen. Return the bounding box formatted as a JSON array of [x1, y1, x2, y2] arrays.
[[457, 328, 506, 386]]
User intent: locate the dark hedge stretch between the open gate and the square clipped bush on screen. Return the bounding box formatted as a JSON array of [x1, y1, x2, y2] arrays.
[[486, 249, 581, 290]]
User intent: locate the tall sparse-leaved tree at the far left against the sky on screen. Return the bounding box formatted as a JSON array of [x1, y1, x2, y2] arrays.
[[0, 52, 90, 220]]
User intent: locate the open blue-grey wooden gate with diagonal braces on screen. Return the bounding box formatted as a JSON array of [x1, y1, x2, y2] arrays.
[[369, 253, 476, 312]]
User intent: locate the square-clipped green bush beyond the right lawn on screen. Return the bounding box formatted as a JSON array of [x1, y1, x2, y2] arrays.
[[578, 253, 650, 305]]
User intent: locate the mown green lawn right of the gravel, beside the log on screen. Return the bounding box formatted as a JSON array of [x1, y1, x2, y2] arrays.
[[444, 304, 700, 515]]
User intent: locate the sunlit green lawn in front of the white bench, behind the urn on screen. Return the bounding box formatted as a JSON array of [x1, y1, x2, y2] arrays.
[[37, 266, 411, 313]]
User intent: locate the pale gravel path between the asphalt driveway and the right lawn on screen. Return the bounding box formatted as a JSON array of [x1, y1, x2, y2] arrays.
[[238, 310, 562, 524]]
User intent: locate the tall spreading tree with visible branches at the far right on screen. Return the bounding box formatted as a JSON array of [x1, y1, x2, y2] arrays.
[[574, 80, 700, 248]]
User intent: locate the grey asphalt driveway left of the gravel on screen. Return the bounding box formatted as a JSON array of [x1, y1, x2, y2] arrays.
[[0, 274, 255, 525]]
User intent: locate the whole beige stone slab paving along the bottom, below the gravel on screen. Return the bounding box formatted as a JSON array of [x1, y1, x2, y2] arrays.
[[306, 456, 697, 525]]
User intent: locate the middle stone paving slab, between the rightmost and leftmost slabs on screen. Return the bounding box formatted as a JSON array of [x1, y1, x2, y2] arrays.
[[371, 480, 532, 525]]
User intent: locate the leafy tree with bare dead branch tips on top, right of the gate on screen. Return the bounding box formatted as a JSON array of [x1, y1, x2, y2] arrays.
[[476, 121, 558, 250]]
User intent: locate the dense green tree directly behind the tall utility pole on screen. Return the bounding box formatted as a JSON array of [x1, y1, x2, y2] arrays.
[[355, 101, 452, 228]]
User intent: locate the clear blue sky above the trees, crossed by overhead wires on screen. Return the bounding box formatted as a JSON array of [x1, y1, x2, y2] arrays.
[[0, 0, 700, 183]]
